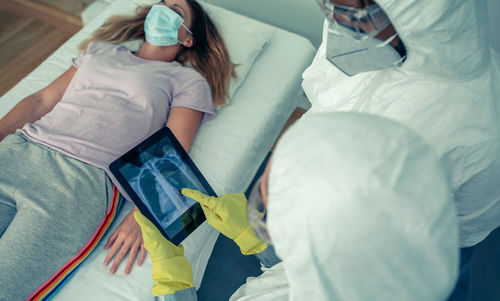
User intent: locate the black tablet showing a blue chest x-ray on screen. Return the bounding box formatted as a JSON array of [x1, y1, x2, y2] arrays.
[[109, 127, 216, 245]]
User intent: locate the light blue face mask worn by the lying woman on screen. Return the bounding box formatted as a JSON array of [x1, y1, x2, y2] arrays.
[[144, 4, 193, 46]]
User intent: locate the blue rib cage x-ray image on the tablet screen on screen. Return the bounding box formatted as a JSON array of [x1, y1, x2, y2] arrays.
[[129, 149, 198, 225]]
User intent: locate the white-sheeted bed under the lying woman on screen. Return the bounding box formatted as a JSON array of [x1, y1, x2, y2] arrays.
[[0, 0, 315, 300]]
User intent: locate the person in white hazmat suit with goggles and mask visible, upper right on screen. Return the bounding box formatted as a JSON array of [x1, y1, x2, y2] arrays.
[[302, 0, 500, 300]]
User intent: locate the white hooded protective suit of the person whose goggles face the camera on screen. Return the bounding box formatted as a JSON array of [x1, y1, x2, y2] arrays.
[[302, 0, 500, 247]]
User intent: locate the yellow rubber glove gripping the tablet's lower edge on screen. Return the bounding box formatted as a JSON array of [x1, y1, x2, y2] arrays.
[[134, 210, 194, 296]]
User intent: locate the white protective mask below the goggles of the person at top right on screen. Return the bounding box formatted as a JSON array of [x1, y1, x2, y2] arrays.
[[326, 23, 405, 76]]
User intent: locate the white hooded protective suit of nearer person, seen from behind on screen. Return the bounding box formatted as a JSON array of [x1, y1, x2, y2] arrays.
[[232, 113, 458, 301]]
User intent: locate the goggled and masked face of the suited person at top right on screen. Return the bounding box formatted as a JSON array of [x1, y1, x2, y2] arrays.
[[317, 0, 406, 76]]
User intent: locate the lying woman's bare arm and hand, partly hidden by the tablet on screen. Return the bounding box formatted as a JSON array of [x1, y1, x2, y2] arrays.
[[104, 107, 203, 274]]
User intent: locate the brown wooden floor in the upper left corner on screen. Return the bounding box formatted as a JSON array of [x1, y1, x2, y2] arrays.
[[0, 0, 94, 96]]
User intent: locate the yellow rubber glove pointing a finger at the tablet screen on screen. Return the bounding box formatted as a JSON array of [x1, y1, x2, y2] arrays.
[[181, 188, 267, 255]]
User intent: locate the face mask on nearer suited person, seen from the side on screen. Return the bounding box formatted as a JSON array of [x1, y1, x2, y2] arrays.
[[247, 177, 272, 245]]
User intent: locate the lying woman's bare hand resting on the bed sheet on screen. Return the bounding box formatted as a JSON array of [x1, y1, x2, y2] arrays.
[[104, 207, 146, 274]]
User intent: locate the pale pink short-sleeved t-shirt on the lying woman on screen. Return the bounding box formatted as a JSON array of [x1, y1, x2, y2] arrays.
[[19, 42, 215, 169]]
